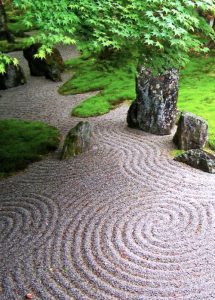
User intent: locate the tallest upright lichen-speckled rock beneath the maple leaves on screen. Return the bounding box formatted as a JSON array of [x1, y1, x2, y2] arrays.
[[127, 67, 178, 135]]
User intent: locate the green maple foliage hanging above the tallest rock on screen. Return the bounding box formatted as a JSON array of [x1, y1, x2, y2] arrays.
[[13, 0, 214, 71]]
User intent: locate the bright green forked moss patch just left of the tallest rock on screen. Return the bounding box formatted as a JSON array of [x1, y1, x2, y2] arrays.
[[59, 58, 136, 117]]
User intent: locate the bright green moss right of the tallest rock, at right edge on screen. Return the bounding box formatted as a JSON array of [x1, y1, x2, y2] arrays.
[[178, 52, 215, 150]]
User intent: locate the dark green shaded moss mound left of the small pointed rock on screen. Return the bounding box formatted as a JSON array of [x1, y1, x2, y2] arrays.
[[0, 120, 59, 177]]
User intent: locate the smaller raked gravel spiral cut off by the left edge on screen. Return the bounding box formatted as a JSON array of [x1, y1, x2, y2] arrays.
[[0, 194, 59, 260]]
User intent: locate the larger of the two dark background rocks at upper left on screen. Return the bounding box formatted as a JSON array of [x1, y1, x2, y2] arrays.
[[23, 44, 64, 81]]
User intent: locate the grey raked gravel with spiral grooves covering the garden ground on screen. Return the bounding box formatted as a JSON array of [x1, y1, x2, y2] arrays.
[[0, 48, 215, 300]]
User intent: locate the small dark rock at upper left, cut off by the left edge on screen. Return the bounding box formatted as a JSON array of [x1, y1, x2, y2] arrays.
[[0, 63, 26, 90]]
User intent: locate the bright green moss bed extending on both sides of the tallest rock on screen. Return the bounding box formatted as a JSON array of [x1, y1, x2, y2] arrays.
[[59, 53, 215, 150]]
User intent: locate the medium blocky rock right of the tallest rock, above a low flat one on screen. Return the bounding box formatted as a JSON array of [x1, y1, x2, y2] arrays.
[[173, 112, 208, 150]]
